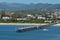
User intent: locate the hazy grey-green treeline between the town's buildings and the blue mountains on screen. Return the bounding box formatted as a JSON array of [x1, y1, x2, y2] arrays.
[[0, 10, 52, 16]]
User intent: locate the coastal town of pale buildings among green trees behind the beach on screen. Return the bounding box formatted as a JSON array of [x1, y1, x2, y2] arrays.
[[0, 11, 60, 23]]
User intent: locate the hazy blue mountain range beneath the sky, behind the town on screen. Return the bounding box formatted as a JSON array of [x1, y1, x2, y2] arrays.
[[0, 2, 60, 11]]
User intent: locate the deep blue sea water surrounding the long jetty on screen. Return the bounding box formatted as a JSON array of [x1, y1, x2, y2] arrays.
[[0, 25, 60, 40]]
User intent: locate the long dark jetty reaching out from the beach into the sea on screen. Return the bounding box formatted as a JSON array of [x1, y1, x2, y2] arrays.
[[16, 25, 48, 32]]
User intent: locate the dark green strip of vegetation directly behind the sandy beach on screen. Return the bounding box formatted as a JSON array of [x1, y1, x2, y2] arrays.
[[0, 20, 47, 23]]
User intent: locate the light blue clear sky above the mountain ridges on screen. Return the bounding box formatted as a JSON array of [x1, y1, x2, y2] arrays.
[[0, 0, 60, 4]]
